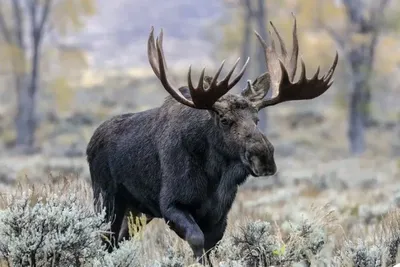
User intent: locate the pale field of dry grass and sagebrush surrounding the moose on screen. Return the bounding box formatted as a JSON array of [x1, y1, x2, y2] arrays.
[[0, 64, 400, 267]]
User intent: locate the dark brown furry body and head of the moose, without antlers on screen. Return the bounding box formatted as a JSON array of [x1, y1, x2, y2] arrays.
[[87, 90, 276, 266]]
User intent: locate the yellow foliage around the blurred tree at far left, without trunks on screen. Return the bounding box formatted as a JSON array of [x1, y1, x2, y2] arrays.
[[0, 0, 96, 111]]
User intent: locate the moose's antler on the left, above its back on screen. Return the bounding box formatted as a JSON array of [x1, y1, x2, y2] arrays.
[[147, 27, 250, 109]]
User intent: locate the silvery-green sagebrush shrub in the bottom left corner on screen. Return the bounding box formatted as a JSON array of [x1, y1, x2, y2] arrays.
[[0, 193, 107, 266]]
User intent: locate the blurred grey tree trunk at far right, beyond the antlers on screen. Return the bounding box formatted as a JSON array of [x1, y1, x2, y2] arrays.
[[343, 0, 389, 155]]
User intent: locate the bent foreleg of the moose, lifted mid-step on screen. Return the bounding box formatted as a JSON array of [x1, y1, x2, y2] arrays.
[[164, 206, 204, 259]]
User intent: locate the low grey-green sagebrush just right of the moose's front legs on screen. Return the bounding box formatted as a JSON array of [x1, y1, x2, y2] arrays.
[[214, 210, 328, 267]]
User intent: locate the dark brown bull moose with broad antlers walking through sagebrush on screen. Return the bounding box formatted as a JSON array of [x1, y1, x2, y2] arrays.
[[86, 14, 338, 263]]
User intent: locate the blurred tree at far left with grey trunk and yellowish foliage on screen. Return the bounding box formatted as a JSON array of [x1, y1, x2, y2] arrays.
[[0, 0, 94, 152]]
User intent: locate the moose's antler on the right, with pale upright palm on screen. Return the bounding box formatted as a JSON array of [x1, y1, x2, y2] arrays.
[[248, 13, 338, 110]]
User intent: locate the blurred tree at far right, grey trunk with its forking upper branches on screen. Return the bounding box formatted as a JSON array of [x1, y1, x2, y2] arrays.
[[319, 0, 390, 154]]
